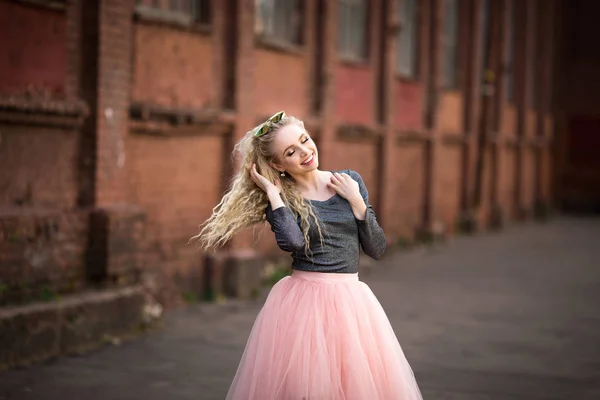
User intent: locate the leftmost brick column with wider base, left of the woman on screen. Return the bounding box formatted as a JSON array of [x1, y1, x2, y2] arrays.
[[82, 0, 145, 284]]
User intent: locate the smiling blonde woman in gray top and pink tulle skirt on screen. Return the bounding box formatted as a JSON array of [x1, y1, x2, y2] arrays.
[[196, 111, 421, 400]]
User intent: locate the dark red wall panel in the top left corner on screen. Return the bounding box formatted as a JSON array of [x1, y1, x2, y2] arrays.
[[0, 1, 67, 95]]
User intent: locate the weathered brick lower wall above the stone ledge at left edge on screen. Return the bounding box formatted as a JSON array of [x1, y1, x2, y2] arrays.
[[0, 208, 89, 306]]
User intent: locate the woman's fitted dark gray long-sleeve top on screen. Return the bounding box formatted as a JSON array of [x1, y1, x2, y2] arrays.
[[266, 170, 386, 273]]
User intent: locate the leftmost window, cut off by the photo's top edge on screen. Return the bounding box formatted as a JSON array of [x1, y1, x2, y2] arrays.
[[137, 0, 210, 25]]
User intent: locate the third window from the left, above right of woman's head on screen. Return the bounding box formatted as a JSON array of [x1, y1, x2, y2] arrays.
[[338, 0, 367, 60]]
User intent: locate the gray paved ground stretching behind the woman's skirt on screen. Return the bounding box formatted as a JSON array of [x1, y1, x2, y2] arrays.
[[0, 219, 600, 400]]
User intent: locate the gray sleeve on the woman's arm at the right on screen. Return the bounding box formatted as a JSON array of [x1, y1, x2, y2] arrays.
[[350, 171, 386, 260]]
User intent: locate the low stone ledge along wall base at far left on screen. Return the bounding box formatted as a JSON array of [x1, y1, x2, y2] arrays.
[[0, 285, 162, 370]]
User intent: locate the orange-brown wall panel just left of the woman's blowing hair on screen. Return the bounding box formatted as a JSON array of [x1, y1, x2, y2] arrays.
[[127, 134, 223, 286]]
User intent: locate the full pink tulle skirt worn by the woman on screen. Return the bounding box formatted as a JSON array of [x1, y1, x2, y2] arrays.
[[227, 271, 421, 400]]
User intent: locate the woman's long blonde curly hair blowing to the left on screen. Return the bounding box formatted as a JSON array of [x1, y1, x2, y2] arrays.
[[190, 116, 323, 254]]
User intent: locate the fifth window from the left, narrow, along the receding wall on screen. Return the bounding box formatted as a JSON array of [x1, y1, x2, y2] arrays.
[[442, 0, 460, 89]]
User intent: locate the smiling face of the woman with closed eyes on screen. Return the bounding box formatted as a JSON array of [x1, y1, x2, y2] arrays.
[[271, 125, 319, 175]]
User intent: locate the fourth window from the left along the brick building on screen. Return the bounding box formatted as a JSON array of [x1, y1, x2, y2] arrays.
[[396, 0, 419, 78]]
